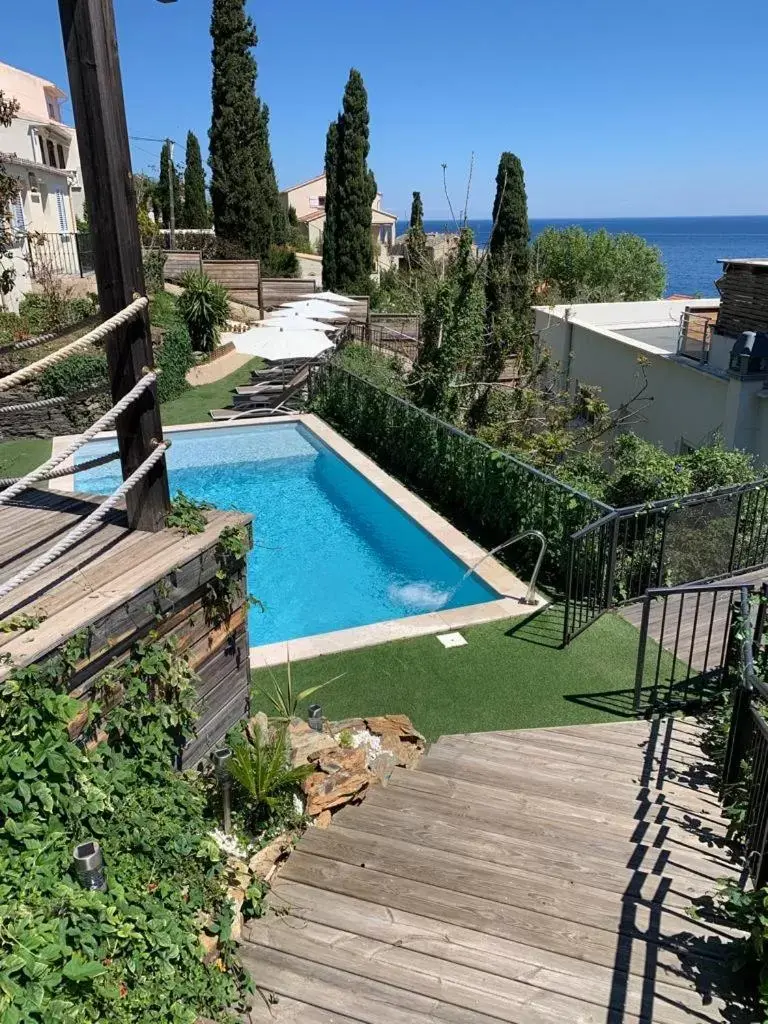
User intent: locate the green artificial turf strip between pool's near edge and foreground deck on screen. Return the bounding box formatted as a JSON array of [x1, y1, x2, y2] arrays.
[[251, 606, 655, 740]]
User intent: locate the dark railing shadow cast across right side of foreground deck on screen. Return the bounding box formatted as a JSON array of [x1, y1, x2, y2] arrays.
[[606, 718, 755, 1024]]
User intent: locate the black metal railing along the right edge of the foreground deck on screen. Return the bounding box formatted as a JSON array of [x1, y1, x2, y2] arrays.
[[722, 584, 768, 889]]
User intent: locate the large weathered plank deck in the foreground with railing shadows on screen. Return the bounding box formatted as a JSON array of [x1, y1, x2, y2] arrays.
[[242, 720, 749, 1024]]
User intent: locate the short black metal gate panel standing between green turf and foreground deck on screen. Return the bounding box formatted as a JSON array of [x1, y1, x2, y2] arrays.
[[634, 584, 754, 714]]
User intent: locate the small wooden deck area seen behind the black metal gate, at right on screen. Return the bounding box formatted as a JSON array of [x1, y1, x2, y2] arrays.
[[618, 568, 768, 672]]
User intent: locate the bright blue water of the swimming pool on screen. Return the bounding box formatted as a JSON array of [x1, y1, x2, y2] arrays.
[[76, 423, 498, 645]]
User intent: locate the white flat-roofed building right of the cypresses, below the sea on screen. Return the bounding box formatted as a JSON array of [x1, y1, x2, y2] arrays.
[[536, 259, 768, 464]]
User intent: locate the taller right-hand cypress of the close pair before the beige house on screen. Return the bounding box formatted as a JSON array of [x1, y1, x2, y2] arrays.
[[335, 68, 376, 293]]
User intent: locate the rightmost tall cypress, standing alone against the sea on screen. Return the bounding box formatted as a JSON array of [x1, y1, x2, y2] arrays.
[[486, 153, 530, 327]]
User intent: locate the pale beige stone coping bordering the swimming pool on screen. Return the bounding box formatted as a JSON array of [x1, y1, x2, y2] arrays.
[[52, 413, 547, 669]]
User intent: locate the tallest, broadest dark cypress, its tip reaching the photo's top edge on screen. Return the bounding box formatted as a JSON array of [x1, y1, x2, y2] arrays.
[[209, 0, 286, 256]]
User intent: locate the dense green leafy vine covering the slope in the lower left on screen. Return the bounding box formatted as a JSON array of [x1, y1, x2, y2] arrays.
[[0, 635, 259, 1024]]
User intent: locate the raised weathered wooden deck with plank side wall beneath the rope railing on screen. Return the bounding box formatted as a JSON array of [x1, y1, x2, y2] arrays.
[[0, 488, 250, 763]]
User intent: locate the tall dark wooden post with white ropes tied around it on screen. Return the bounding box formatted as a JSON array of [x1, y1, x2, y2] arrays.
[[58, 0, 170, 531]]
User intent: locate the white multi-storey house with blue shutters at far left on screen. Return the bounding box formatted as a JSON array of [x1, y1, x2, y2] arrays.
[[0, 63, 85, 308]]
